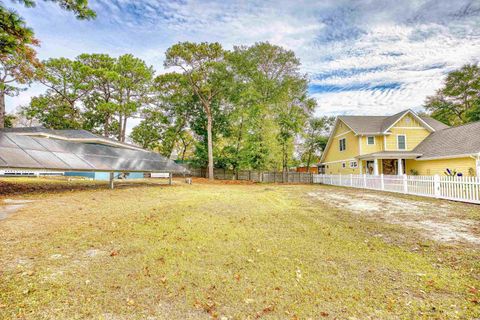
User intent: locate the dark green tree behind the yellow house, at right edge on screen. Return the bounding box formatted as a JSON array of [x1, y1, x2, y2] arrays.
[[425, 64, 480, 125]]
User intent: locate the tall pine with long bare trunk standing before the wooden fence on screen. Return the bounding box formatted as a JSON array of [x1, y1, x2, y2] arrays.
[[164, 42, 228, 180]]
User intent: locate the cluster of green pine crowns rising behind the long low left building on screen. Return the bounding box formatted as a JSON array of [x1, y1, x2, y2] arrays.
[[22, 54, 154, 141]]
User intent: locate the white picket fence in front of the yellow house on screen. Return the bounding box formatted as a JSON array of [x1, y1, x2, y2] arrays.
[[313, 174, 480, 204]]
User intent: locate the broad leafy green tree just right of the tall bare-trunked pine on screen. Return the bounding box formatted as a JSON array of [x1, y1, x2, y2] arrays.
[[229, 42, 315, 170]]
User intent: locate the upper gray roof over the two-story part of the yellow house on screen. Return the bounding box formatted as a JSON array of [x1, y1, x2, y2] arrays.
[[338, 110, 449, 134]]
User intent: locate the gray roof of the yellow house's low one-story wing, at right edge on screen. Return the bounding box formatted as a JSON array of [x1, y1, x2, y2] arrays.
[[413, 121, 480, 159]]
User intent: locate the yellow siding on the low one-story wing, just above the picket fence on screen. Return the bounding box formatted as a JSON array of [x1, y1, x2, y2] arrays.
[[407, 158, 475, 176]]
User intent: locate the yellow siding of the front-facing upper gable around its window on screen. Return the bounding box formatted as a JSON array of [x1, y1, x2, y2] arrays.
[[385, 114, 430, 151]]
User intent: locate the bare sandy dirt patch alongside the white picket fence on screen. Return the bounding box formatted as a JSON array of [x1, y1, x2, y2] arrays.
[[308, 188, 480, 245]]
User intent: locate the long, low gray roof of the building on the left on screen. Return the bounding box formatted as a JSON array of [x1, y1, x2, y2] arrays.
[[0, 131, 187, 172]]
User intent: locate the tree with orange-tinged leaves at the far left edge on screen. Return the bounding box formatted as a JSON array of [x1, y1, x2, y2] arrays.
[[0, 7, 40, 128]]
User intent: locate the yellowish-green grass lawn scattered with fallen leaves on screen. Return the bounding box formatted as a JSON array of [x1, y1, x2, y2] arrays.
[[0, 179, 480, 319]]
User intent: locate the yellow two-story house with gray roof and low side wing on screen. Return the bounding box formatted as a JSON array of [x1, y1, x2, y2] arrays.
[[319, 110, 480, 176]]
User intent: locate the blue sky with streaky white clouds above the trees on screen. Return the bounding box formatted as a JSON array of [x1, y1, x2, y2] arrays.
[[3, 0, 480, 125]]
